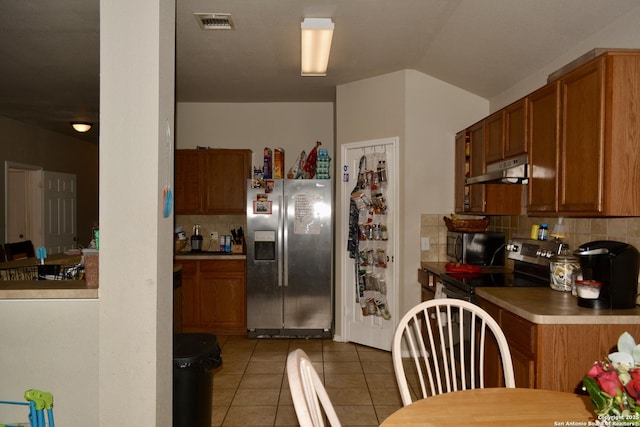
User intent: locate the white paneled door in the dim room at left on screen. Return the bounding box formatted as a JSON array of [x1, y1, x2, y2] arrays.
[[44, 171, 77, 254]]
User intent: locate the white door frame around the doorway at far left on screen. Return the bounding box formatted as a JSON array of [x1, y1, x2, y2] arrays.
[[4, 160, 44, 246]]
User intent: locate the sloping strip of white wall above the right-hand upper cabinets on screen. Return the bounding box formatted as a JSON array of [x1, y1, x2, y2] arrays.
[[492, 8, 640, 110]]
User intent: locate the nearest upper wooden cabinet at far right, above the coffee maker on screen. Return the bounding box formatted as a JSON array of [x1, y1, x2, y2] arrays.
[[529, 51, 640, 216]]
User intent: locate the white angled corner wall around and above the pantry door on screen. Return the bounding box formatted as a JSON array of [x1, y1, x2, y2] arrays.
[[336, 70, 489, 331]]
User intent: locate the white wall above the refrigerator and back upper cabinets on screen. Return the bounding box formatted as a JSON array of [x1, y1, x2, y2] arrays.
[[176, 102, 335, 171]]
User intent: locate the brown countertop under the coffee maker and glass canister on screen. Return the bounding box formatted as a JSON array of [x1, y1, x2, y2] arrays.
[[476, 287, 640, 325]]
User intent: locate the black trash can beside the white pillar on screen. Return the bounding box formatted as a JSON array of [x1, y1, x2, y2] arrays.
[[173, 334, 222, 427]]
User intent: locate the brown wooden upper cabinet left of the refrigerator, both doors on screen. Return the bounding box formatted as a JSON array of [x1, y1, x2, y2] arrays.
[[175, 149, 251, 215]]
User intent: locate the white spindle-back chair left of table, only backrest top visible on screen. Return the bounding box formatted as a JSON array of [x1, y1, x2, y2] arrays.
[[287, 349, 340, 427]]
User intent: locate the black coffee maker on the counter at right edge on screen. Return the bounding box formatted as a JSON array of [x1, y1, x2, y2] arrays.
[[575, 240, 640, 309]]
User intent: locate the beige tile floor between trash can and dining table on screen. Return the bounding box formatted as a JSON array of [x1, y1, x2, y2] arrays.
[[211, 336, 402, 426]]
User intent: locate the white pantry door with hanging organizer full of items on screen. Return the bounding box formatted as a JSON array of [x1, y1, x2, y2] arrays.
[[340, 138, 399, 350]]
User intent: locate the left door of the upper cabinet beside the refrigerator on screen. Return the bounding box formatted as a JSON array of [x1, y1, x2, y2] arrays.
[[174, 150, 201, 215]]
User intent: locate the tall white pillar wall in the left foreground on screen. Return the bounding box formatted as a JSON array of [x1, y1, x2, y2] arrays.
[[98, 0, 175, 427]]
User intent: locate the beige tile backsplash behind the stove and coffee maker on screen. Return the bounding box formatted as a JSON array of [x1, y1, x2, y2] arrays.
[[420, 214, 640, 262]]
